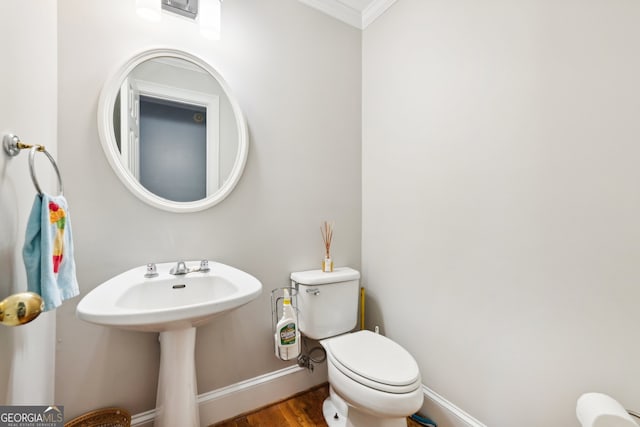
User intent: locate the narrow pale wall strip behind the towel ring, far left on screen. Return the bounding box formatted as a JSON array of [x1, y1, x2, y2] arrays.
[[0, 0, 58, 405]]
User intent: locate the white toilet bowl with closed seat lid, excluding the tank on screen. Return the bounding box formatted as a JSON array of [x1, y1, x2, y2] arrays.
[[320, 331, 423, 427]]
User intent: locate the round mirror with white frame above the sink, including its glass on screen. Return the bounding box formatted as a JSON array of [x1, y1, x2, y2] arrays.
[[98, 49, 249, 212]]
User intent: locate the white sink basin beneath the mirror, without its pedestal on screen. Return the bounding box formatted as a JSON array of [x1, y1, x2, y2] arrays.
[[77, 261, 262, 332]]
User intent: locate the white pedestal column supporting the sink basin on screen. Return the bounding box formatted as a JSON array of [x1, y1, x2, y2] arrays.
[[154, 327, 200, 427]]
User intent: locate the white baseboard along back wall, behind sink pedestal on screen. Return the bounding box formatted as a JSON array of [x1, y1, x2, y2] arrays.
[[131, 365, 327, 427]]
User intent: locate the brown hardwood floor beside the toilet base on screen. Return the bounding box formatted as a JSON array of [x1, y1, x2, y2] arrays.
[[209, 384, 419, 427]]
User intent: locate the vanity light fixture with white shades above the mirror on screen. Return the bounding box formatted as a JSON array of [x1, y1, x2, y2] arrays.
[[136, 0, 222, 40]]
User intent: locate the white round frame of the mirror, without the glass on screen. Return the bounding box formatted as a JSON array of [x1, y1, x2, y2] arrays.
[[98, 48, 249, 212]]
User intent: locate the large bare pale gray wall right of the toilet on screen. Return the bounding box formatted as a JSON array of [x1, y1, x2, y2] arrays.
[[362, 0, 640, 427]]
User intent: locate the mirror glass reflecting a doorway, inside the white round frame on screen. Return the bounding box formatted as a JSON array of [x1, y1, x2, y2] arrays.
[[113, 57, 229, 202]]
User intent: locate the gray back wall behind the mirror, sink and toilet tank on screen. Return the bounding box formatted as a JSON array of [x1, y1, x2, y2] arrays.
[[56, 0, 361, 416]]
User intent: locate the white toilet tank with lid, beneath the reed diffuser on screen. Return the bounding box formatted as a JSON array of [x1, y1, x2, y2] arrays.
[[291, 267, 360, 340]]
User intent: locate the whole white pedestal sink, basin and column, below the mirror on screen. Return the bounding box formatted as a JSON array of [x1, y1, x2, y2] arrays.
[[76, 261, 262, 427]]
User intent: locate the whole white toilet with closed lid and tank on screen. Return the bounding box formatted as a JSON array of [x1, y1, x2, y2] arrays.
[[291, 267, 423, 427]]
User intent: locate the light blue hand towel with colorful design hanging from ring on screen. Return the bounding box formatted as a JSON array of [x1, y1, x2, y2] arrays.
[[22, 194, 80, 311]]
